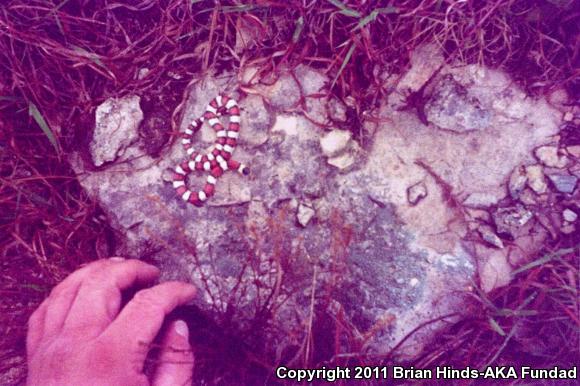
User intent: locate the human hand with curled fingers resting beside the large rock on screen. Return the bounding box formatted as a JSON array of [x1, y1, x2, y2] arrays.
[[26, 258, 195, 385]]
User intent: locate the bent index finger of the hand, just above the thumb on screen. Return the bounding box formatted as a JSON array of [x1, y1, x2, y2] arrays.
[[101, 281, 196, 363]]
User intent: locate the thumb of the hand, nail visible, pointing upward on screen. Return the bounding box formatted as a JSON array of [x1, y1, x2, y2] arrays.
[[152, 320, 193, 386]]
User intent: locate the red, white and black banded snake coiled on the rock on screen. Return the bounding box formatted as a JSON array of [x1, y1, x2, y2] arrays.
[[173, 95, 249, 207]]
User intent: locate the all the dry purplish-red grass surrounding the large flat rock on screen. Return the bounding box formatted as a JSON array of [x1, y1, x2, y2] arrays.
[[0, 0, 580, 383]]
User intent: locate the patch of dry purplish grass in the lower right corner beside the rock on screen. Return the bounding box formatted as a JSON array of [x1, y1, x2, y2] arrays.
[[413, 245, 580, 385]]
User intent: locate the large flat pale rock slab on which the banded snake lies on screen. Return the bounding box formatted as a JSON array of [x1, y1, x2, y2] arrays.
[[71, 58, 561, 362]]
